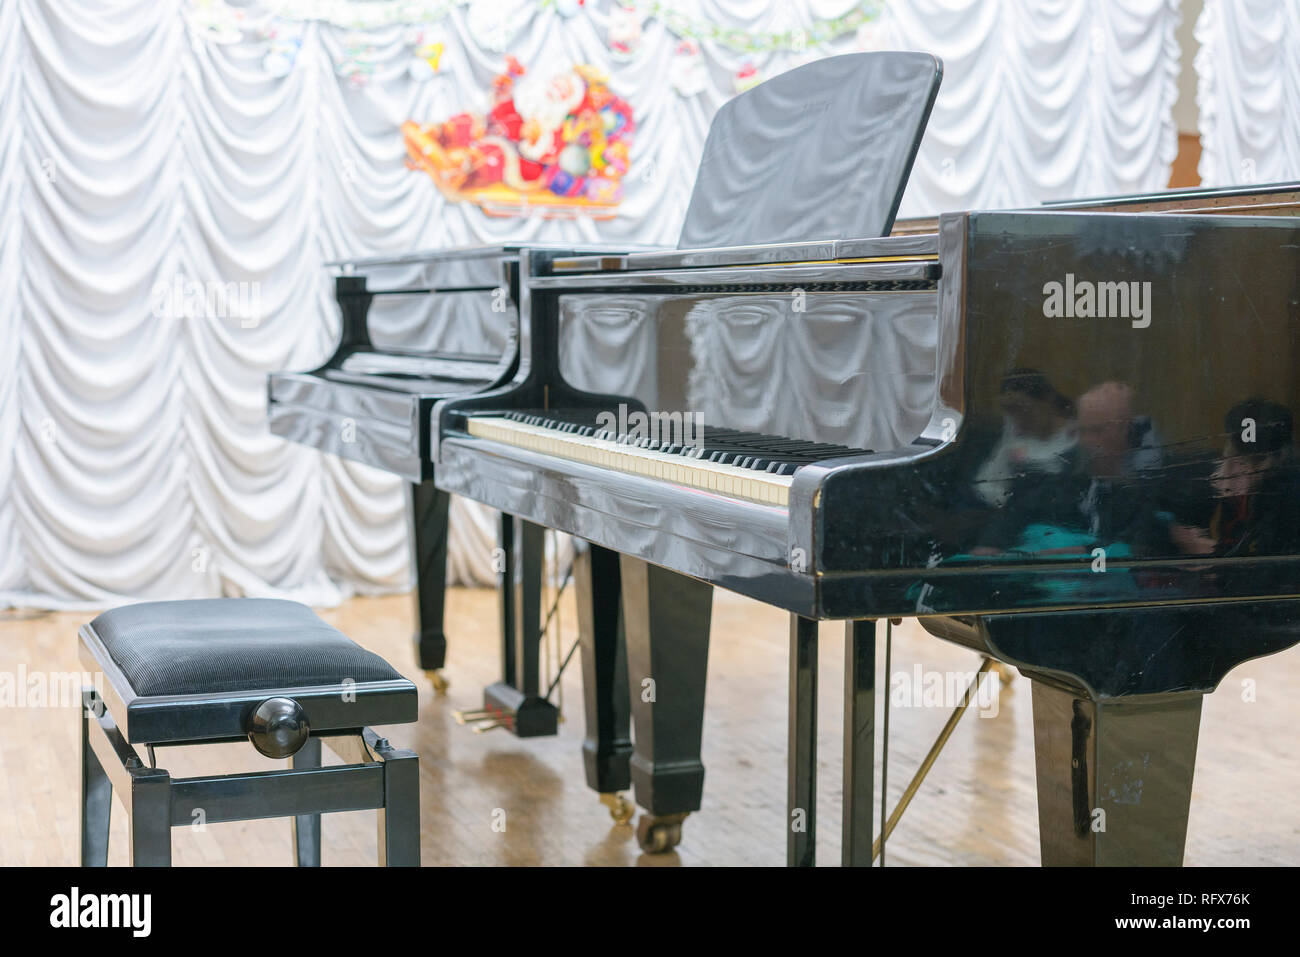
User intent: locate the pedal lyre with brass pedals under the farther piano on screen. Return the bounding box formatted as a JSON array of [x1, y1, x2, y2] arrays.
[[480, 515, 559, 737]]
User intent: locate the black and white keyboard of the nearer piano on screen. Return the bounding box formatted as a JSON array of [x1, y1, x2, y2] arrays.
[[467, 410, 867, 507]]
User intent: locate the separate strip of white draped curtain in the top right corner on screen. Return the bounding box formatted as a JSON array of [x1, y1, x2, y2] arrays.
[[1196, 0, 1300, 186]]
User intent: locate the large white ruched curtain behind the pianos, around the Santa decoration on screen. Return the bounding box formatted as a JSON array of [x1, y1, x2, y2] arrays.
[[0, 0, 1180, 607]]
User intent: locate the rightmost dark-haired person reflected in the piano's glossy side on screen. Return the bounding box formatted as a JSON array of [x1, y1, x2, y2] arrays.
[[1170, 399, 1300, 557]]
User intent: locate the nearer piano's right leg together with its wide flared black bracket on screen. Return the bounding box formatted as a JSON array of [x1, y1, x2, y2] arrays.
[[922, 599, 1300, 866]]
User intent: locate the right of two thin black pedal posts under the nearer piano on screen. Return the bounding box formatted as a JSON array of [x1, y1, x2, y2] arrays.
[[840, 619, 876, 867]]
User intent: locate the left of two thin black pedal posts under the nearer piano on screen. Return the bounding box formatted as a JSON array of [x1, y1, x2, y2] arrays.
[[785, 615, 816, 867]]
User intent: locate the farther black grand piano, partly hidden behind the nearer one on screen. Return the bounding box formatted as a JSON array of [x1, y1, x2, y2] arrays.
[[268, 244, 644, 737]]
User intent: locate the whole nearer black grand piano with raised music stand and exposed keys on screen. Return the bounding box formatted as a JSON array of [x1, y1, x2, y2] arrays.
[[429, 53, 1300, 865]]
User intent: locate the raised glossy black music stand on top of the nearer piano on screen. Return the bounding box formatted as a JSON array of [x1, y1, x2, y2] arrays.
[[677, 53, 943, 248]]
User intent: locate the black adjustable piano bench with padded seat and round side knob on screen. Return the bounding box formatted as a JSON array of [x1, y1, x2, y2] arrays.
[[78, 598, 420, 867]]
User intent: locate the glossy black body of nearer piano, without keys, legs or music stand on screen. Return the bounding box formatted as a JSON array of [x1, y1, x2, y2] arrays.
[[439, 212, 1300, 618]]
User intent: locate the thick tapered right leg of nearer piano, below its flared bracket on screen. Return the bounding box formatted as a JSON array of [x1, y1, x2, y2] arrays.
[[1032, 679, 1203, 867]]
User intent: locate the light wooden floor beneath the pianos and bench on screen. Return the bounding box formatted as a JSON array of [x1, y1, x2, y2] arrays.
[[0, 589, 1300, 866]]
